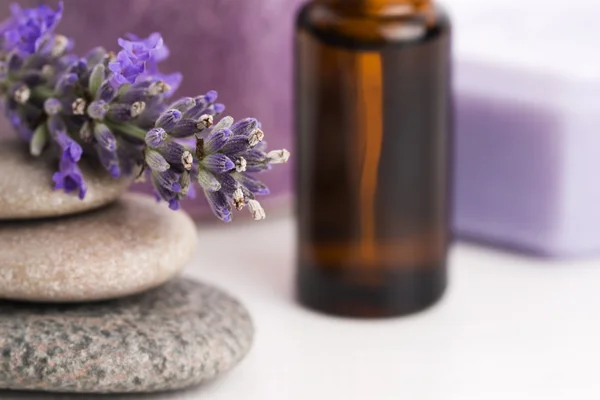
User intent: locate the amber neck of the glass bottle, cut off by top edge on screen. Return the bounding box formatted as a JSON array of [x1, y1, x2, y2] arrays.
[[314, 0, 433, 16]]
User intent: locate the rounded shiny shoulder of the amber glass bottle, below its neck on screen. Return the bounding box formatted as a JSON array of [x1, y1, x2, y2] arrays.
[[296, 2, 451, 49]]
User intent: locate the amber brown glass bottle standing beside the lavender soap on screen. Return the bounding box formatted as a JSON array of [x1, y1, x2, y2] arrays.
[[296, 0, 451, 317]]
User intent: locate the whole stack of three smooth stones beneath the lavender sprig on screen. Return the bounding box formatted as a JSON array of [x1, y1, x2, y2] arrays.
[[0, 140, 253, 397]]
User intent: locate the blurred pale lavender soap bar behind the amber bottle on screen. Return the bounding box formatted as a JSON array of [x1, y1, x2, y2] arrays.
[[454, 61, 600, 257]]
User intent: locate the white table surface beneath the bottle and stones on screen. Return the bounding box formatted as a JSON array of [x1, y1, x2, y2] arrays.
[[0, 217, 600, 400]]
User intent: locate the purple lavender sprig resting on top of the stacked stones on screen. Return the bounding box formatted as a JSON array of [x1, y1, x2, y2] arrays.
[[0, 3, 289, 222]]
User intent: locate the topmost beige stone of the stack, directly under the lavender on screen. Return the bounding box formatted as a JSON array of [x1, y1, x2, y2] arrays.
[[0, 139, 131, 220]]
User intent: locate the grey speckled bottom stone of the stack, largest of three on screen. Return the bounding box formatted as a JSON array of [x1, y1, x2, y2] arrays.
[[0, 278, 253, 393]]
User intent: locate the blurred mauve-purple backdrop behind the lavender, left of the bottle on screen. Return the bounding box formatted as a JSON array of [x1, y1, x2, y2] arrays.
[[0, 0, 301, 217]]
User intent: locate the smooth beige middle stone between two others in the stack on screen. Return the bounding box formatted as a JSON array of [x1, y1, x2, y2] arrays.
[[0, 193, 197, 302]]
